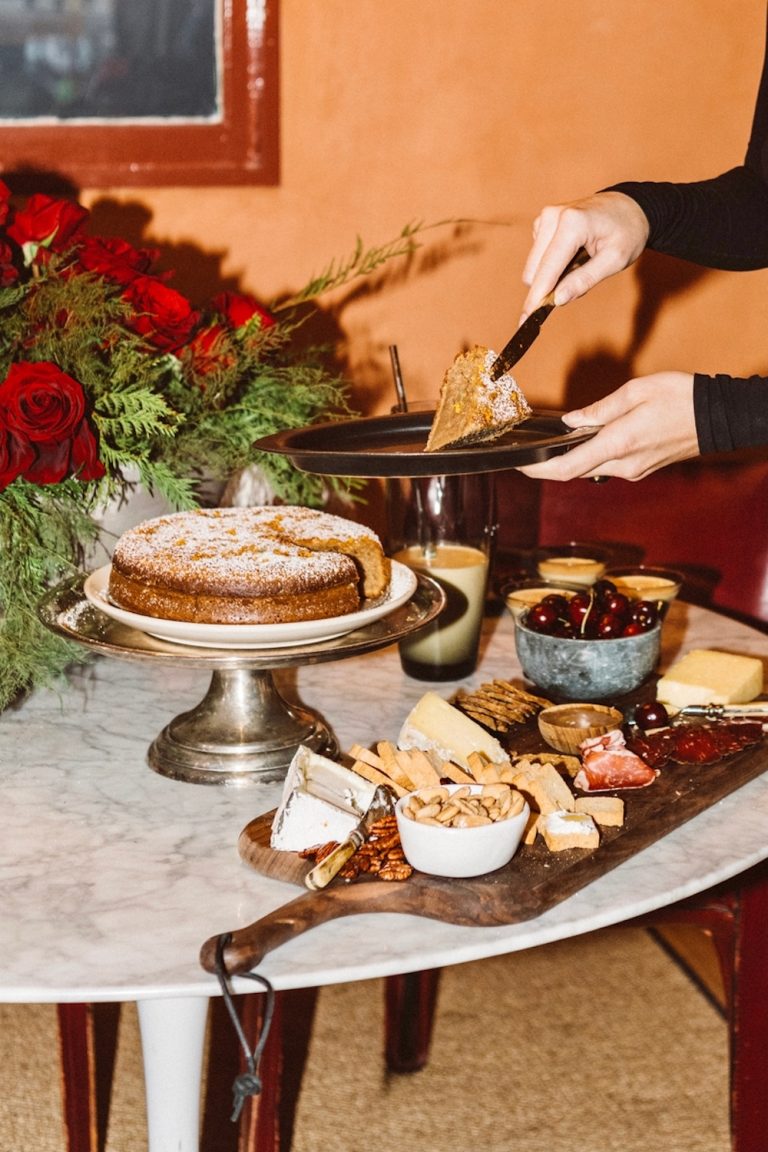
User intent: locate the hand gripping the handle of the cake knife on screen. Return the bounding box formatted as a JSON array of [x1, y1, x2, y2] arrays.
[[520, 192, 649, 323]]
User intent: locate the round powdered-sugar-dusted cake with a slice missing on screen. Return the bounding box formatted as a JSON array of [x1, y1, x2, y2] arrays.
[[108, 506, 390, 624]]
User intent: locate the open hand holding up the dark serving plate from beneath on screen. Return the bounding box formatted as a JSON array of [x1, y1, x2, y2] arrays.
[[519, 372, 699, 480]]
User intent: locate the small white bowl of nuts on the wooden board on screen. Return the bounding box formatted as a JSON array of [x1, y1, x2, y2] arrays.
[[395, 783, 530, 877]]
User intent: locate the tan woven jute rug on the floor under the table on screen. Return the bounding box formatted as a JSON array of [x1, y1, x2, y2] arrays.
[[0, 929, 730, 1152]]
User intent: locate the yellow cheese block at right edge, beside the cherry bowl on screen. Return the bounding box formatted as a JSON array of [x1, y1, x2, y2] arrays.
[[656, 649, 762, 708]]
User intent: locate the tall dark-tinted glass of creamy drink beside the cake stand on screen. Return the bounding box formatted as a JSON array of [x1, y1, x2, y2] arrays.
[[387, 473, 496, 681]]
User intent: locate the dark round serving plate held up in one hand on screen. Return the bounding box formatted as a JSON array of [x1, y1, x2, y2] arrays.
[[253, 411, 598, 477]]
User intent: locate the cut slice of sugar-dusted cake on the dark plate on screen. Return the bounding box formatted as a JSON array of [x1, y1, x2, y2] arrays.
[[426, 344, 531, 452]]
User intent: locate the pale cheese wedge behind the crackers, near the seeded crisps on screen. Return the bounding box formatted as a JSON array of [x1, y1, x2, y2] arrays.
[[397, 692, 509, 773]]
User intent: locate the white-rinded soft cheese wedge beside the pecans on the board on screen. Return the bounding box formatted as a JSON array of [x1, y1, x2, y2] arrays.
[[269, 744, 377, 852]]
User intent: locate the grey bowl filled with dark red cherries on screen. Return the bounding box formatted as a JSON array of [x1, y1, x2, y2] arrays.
[[515, 578, 662, 700]]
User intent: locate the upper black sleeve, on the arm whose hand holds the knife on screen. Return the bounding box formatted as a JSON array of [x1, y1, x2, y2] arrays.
[[610, 11, 768, 271]]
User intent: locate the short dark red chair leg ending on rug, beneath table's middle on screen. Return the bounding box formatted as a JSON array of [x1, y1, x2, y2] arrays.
[[385, 968, 440, 1073]]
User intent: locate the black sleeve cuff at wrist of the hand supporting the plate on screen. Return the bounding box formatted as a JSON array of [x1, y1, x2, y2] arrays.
[[693, 372, 768, 454]]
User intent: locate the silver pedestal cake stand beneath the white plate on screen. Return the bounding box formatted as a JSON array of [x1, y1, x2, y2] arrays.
[[39, 575, 444, 787]]
